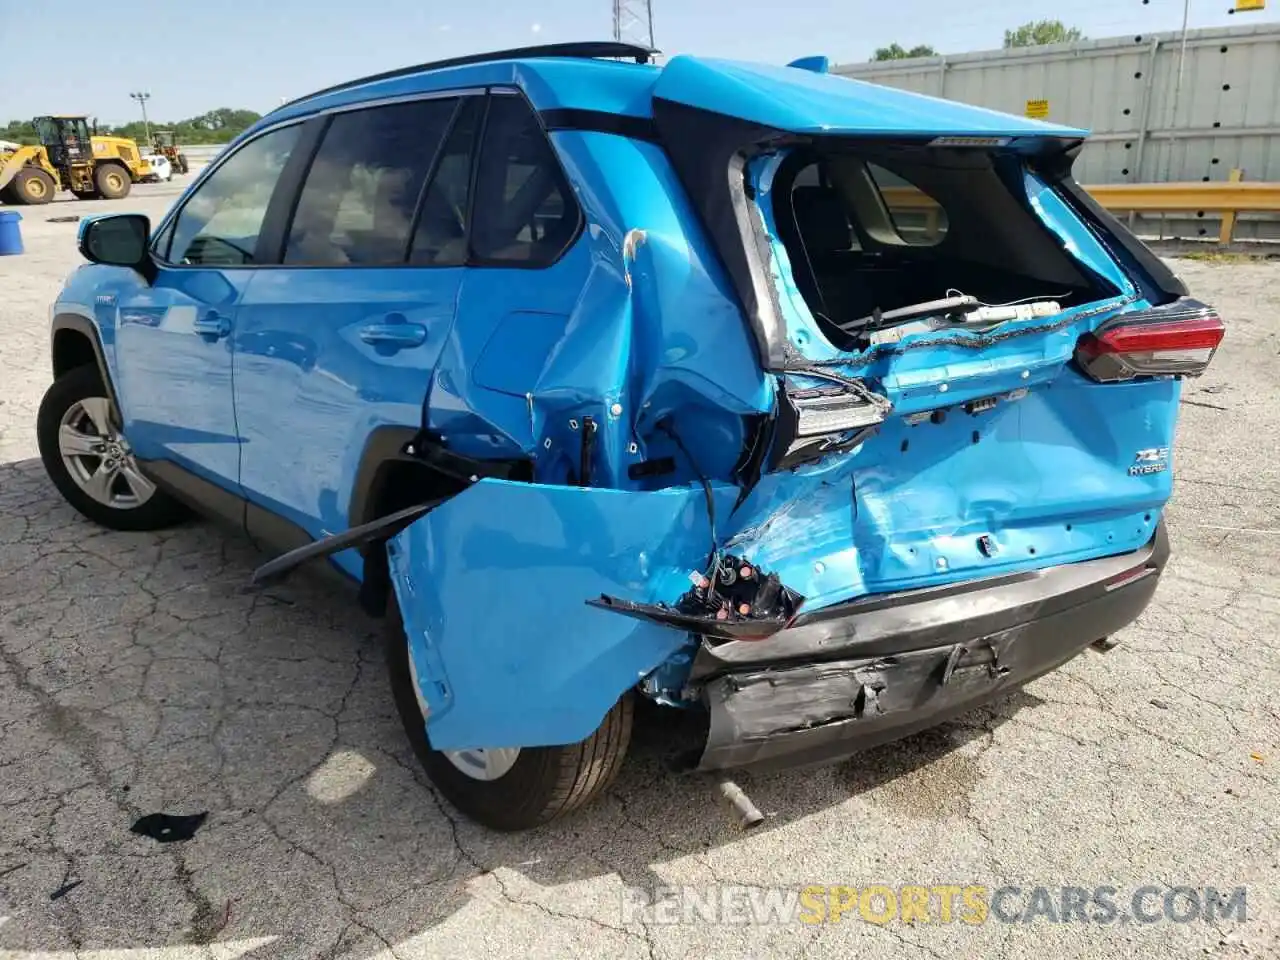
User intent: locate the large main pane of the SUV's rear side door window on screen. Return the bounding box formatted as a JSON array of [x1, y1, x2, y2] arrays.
[[284, 99, 457, 266]]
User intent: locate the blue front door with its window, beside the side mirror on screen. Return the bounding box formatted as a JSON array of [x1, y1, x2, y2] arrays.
[[114, 127, 298, 492]]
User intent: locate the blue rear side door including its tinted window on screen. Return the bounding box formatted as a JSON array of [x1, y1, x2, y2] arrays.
[[236, 93, 483, 572]]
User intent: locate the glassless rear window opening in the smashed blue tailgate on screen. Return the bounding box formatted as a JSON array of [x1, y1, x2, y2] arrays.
[[771, 142, 1117, 351]]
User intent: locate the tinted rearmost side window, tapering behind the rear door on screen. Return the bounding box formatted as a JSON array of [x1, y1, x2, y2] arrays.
[[471, 96, 579, 266]]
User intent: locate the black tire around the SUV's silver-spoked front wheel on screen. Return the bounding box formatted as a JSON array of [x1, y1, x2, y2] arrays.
[[36, 366, 189, 530]]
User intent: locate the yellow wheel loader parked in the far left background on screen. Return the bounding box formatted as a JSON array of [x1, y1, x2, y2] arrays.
[[0, 116, 151, 204]]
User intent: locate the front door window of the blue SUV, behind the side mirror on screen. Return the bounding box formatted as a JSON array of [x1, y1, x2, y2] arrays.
[[165, 124, 301, 266]]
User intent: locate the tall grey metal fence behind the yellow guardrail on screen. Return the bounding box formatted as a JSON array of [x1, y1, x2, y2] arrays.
[[835, 23, 1280, 239]]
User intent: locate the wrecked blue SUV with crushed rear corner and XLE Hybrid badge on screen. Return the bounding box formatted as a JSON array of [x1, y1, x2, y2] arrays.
[[38, 44, 1224, 829]]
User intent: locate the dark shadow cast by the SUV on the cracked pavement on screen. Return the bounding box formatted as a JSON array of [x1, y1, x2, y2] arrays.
[[0, 460, 1039, 959]]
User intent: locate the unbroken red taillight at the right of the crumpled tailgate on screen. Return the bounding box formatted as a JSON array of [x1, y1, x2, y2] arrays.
[[1075, 300, 1226, 381]]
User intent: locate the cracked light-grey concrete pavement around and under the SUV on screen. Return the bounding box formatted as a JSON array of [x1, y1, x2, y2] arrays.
[[0, 186, 1280, 960]]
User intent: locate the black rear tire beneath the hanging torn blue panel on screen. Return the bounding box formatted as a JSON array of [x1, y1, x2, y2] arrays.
[[387, 594, 634, 832]]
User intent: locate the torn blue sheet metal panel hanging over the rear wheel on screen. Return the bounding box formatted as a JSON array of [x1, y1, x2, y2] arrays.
[[388, 479, 736, 750]]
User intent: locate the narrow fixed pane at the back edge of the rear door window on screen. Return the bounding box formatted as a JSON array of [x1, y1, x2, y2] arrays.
[[410, 96, 485, 266]]
